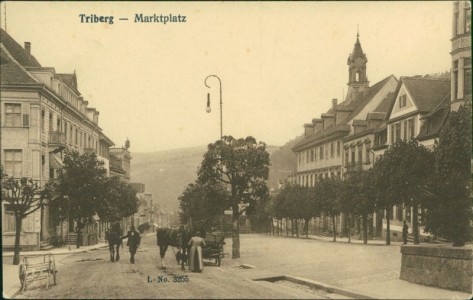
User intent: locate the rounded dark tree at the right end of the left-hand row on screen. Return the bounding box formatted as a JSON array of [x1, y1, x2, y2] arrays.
[[96, 176, 139, 222]]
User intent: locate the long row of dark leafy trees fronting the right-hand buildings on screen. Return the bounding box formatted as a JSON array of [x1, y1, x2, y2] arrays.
[[268, 106, 472, 246]]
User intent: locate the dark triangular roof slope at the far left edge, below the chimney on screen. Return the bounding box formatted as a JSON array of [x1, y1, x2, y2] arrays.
[[0, 47, 37, 84]]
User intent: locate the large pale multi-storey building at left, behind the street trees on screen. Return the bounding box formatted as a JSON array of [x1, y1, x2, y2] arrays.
[[0, 30, 113, 249]]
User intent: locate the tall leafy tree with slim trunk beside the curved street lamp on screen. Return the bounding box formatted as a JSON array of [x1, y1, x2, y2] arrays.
[[198, 136, 270, 258]]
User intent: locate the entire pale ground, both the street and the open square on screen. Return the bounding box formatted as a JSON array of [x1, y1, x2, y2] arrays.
[[4, 234, 470, 299]]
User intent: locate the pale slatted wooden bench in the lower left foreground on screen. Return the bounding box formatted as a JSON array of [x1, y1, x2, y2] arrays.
[[19, 253, 57, 291]]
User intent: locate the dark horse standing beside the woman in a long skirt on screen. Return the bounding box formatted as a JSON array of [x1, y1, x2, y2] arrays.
[[156, 220, 205, 270]]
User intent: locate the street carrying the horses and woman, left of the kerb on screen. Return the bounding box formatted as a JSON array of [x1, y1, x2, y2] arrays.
[[17, 236, 327, 299]]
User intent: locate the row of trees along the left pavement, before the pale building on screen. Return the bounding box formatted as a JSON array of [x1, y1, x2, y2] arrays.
[[1, 151, 139, 264]]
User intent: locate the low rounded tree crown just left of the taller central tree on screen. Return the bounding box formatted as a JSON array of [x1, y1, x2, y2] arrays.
[[179, 182, 228, 224]]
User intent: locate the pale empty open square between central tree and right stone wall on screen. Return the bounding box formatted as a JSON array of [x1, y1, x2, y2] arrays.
[[232, 234, 401, 287]]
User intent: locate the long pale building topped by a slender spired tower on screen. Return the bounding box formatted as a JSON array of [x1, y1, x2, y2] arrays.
[[289, 34, 398, 237]]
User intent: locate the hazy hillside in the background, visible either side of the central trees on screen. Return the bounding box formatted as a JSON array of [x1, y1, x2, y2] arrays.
[[131, 137, 300, 212]]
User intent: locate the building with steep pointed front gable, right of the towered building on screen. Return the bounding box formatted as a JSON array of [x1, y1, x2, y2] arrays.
[[372, 76, 450, 240]]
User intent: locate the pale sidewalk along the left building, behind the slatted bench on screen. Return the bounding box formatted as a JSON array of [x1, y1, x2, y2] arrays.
[[2, 241, 108, 298]]
